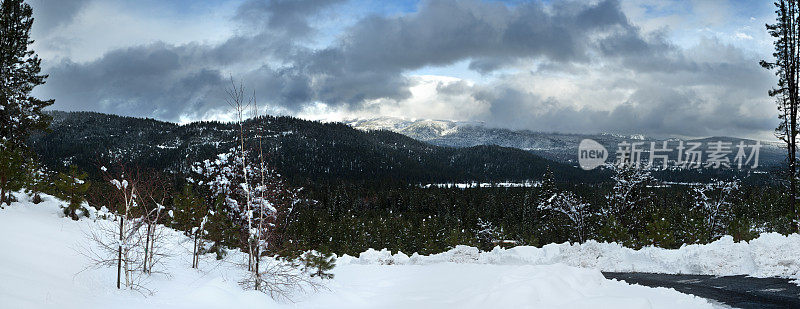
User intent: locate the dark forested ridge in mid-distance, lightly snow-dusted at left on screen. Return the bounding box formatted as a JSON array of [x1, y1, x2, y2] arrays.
[[30, 112, 600, 183]]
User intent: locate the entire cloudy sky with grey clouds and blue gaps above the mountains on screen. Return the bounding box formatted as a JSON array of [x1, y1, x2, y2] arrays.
[[29, 0, 777, 138]]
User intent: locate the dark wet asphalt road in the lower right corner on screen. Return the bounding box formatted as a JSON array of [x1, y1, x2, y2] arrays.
[[603, 272, 800, 308]]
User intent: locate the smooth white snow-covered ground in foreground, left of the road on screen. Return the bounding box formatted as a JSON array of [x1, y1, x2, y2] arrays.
[[0, 191, 711, 309]]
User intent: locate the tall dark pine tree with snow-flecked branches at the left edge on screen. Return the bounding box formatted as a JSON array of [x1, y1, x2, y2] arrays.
[[0, 0, 53, 203]]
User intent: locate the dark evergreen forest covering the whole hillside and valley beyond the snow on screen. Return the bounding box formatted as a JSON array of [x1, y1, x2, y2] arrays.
[[21, 112, 788, 253]]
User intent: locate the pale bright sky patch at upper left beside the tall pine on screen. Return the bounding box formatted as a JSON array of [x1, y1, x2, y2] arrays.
[[32, 0, 242, 62]]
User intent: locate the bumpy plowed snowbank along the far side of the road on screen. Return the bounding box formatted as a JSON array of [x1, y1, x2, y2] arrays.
[[339, 233, 800, 278]]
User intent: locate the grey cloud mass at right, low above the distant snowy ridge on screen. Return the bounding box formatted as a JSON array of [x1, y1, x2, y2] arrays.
[[472, 39, 775, 136]]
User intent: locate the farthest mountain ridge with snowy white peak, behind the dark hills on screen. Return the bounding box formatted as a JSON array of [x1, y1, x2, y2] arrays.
[[345, 117, 785, 169]]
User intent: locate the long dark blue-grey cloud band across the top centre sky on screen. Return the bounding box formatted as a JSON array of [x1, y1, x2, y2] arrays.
[[267, 0, 638, 107]]
